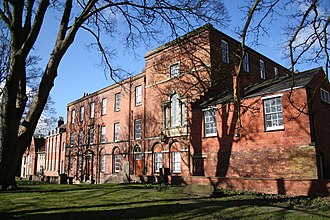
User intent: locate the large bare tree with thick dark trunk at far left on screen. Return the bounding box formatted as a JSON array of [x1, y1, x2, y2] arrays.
[[0, 0, 227, 190]]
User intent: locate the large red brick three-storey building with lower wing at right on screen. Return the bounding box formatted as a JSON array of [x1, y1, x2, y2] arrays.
[[65, 25, 330, 193]]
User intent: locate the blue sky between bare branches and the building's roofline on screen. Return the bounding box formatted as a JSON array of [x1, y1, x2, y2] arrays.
[[35, 0, 327, 119]]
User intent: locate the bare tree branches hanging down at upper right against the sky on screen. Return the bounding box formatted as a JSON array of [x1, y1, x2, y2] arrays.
[[234, 0, 330, 131]]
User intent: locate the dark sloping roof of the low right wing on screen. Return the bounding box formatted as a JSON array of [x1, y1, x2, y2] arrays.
[[199, 67, 323, 108]]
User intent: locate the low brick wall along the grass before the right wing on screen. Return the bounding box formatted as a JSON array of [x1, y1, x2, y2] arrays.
[[187, 176, 330, 196]]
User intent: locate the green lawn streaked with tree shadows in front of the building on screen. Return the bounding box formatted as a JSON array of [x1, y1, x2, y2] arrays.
[[0, 182, 330, 220]]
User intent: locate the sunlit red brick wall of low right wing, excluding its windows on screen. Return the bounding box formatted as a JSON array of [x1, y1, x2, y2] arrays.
[[192, 88, 318, 179]]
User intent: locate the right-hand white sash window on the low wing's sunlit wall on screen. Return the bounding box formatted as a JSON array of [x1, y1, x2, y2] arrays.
[[262, 96, 284, 131]]
